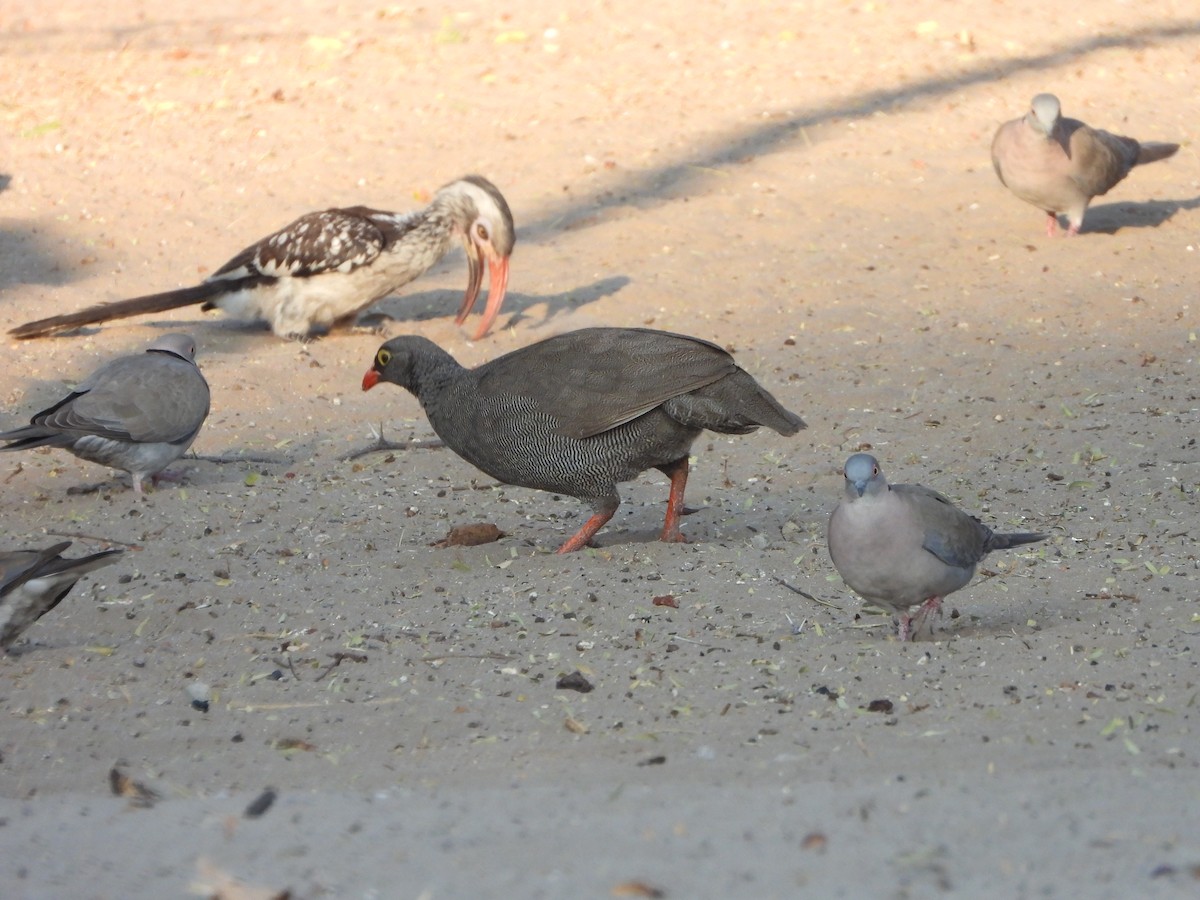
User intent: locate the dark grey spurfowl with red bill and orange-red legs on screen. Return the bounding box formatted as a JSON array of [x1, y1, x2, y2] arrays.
[[362, 328, 804, 553]]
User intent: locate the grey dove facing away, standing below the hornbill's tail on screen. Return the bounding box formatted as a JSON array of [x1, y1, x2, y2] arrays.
[[0, 334, 209, 493]]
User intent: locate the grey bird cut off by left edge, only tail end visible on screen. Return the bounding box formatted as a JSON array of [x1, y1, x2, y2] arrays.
[[0, 541, 125, 650]]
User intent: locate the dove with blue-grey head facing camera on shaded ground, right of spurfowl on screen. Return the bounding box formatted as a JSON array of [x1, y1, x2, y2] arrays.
[[828, 454, 1050, 641]]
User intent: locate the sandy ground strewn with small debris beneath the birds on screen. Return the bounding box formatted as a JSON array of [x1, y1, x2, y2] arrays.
[[0, 0, 1200, 900]]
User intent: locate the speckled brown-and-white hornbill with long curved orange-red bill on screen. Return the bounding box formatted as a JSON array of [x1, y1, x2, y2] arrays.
[[10, 175, 516, 341]]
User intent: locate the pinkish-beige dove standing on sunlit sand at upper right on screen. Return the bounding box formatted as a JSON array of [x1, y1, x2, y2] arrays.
[[991, 94, 1180, 236]]
